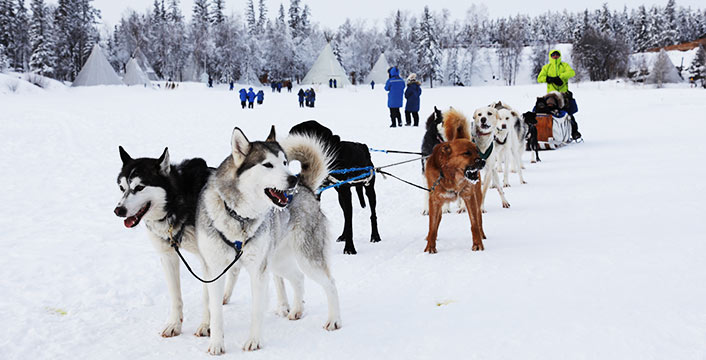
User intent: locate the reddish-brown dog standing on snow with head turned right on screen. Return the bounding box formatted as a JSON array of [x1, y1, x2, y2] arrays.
[[424, 139, 485, 254]]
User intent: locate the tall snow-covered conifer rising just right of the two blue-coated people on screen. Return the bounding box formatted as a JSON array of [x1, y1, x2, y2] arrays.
[[417, 6, 443, 87]]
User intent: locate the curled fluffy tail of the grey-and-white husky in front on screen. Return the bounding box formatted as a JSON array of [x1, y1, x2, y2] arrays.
[[280, 134, 333, 191]]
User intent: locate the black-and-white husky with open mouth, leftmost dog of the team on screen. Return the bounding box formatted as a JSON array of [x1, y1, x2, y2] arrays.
[[114, 146, 237, 337]]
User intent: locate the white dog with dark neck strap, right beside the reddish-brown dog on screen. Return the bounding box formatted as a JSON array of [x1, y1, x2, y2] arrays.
[[473, 106, 510, 212]]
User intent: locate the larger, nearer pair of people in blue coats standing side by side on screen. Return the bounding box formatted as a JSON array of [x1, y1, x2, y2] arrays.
[[382, 66, 422, 128]]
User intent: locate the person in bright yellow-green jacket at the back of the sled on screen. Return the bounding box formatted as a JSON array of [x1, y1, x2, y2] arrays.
[[537, 50, 581, 140]]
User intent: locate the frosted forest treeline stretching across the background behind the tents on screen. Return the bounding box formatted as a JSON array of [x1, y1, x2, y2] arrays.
[[0, 0, 706, 84]]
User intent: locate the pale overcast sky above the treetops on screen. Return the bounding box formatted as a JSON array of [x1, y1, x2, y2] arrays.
[[64, 0, 704, 28]]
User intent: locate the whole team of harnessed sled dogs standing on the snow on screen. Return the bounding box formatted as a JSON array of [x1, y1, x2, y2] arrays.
[[114, 102, 529, 355]]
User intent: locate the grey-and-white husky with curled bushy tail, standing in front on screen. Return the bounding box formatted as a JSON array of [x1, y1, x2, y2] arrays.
[[196, 126, 341, 355]]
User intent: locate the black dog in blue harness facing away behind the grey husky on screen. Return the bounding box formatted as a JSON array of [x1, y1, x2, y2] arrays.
[[289, 120, 381, 255]]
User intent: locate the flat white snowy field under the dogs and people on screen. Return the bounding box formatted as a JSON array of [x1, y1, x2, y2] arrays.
[[0, 82, 706, 360]]
